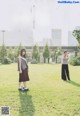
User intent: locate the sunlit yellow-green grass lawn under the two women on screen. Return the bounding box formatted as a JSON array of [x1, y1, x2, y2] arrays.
[[0, 64, 80, 116]]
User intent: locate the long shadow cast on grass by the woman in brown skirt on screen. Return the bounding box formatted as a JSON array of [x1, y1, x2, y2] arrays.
[[19, 92, 35, 116]]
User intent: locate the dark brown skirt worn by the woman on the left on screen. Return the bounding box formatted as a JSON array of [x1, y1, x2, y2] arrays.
[[19, 69, 29, 82]]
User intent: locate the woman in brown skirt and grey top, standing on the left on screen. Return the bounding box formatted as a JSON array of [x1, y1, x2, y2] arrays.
[[18, 49, 29, 91]]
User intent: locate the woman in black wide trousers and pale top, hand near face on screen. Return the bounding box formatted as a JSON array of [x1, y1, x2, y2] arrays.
[[61, 51, 70, 80]]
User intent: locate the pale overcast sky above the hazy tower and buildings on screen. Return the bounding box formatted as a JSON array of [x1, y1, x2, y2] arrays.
[[0, 0, 80, 44]]
